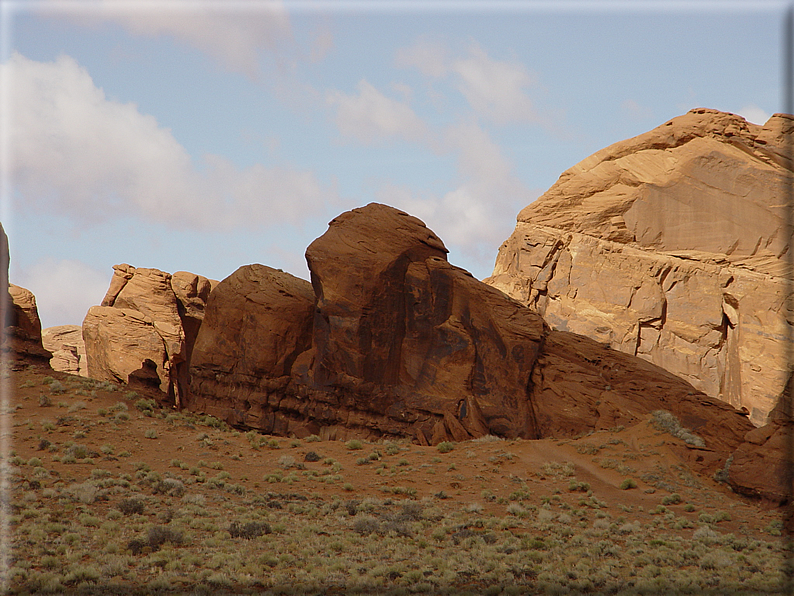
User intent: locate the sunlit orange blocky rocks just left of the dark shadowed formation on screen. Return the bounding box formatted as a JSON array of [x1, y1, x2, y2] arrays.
[[83, 264, 211, 406]]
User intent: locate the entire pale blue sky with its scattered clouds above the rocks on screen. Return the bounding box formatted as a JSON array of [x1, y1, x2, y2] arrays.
[[0, 0, 787, 327]]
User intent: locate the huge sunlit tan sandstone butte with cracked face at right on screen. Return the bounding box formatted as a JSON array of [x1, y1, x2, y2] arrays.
[[486, 108, 794, 425]]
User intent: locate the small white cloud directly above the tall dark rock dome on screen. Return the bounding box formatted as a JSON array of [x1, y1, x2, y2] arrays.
[[327, 79, 427, 143]]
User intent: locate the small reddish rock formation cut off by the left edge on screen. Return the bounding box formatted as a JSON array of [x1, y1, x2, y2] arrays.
[[0, 224, 52, 362]]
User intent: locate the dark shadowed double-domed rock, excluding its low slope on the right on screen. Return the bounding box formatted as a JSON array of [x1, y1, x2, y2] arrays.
[[190, 204, 544, 443]]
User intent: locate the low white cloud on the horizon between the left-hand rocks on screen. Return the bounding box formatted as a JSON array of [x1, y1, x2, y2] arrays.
[[11, 258, 112, 328]]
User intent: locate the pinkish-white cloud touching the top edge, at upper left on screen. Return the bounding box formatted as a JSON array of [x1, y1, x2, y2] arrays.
[[38, 0, 290, 76]]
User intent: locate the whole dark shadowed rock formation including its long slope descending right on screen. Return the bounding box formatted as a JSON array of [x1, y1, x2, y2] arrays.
[[184, 204, 753, 478]]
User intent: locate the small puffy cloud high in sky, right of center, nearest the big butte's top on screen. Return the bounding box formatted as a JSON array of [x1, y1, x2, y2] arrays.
[[452, 45, 537, 125]]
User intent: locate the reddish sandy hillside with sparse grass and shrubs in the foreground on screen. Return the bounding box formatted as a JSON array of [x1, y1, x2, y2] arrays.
[[2, 369, 783, 595]]
